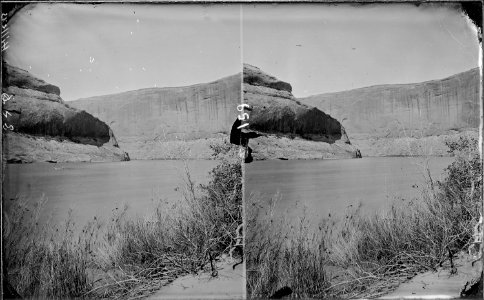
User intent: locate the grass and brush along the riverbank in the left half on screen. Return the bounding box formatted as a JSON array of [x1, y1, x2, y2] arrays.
[[3, 142, 242, 299]]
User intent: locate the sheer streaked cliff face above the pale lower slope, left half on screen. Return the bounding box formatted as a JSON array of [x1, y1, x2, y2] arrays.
[[69, 75, 240, 140]]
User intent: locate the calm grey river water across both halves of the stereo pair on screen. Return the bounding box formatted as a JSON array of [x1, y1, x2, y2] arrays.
[[3, 157, 452, 230]]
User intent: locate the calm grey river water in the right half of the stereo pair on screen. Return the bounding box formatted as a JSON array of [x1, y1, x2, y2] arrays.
[[245, 157, 453, 220]]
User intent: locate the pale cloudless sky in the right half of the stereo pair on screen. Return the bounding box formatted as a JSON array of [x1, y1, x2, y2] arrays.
[[242, 4, 479, 97]]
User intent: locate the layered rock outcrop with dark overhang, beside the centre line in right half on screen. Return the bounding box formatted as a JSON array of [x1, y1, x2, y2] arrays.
[[243, 64, 356, 159]]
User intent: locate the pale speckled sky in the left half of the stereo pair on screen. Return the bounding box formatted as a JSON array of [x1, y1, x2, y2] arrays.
[[6, 3, 241, 101]]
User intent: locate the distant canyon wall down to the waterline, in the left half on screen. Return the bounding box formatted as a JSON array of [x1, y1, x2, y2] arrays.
[[68, 74, 241, 159]]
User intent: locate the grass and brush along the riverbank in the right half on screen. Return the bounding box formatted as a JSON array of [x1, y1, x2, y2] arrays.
[[245, 138, 482, 298]]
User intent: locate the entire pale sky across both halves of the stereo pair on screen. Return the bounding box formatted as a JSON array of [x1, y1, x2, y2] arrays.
[[6, 3, 479, 101]]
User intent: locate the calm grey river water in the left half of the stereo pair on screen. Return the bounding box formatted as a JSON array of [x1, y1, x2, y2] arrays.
[[3, 160, 218, 226]]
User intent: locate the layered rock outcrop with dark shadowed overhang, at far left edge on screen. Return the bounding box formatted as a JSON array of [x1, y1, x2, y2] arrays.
[[2, 63, 128, 162]]
